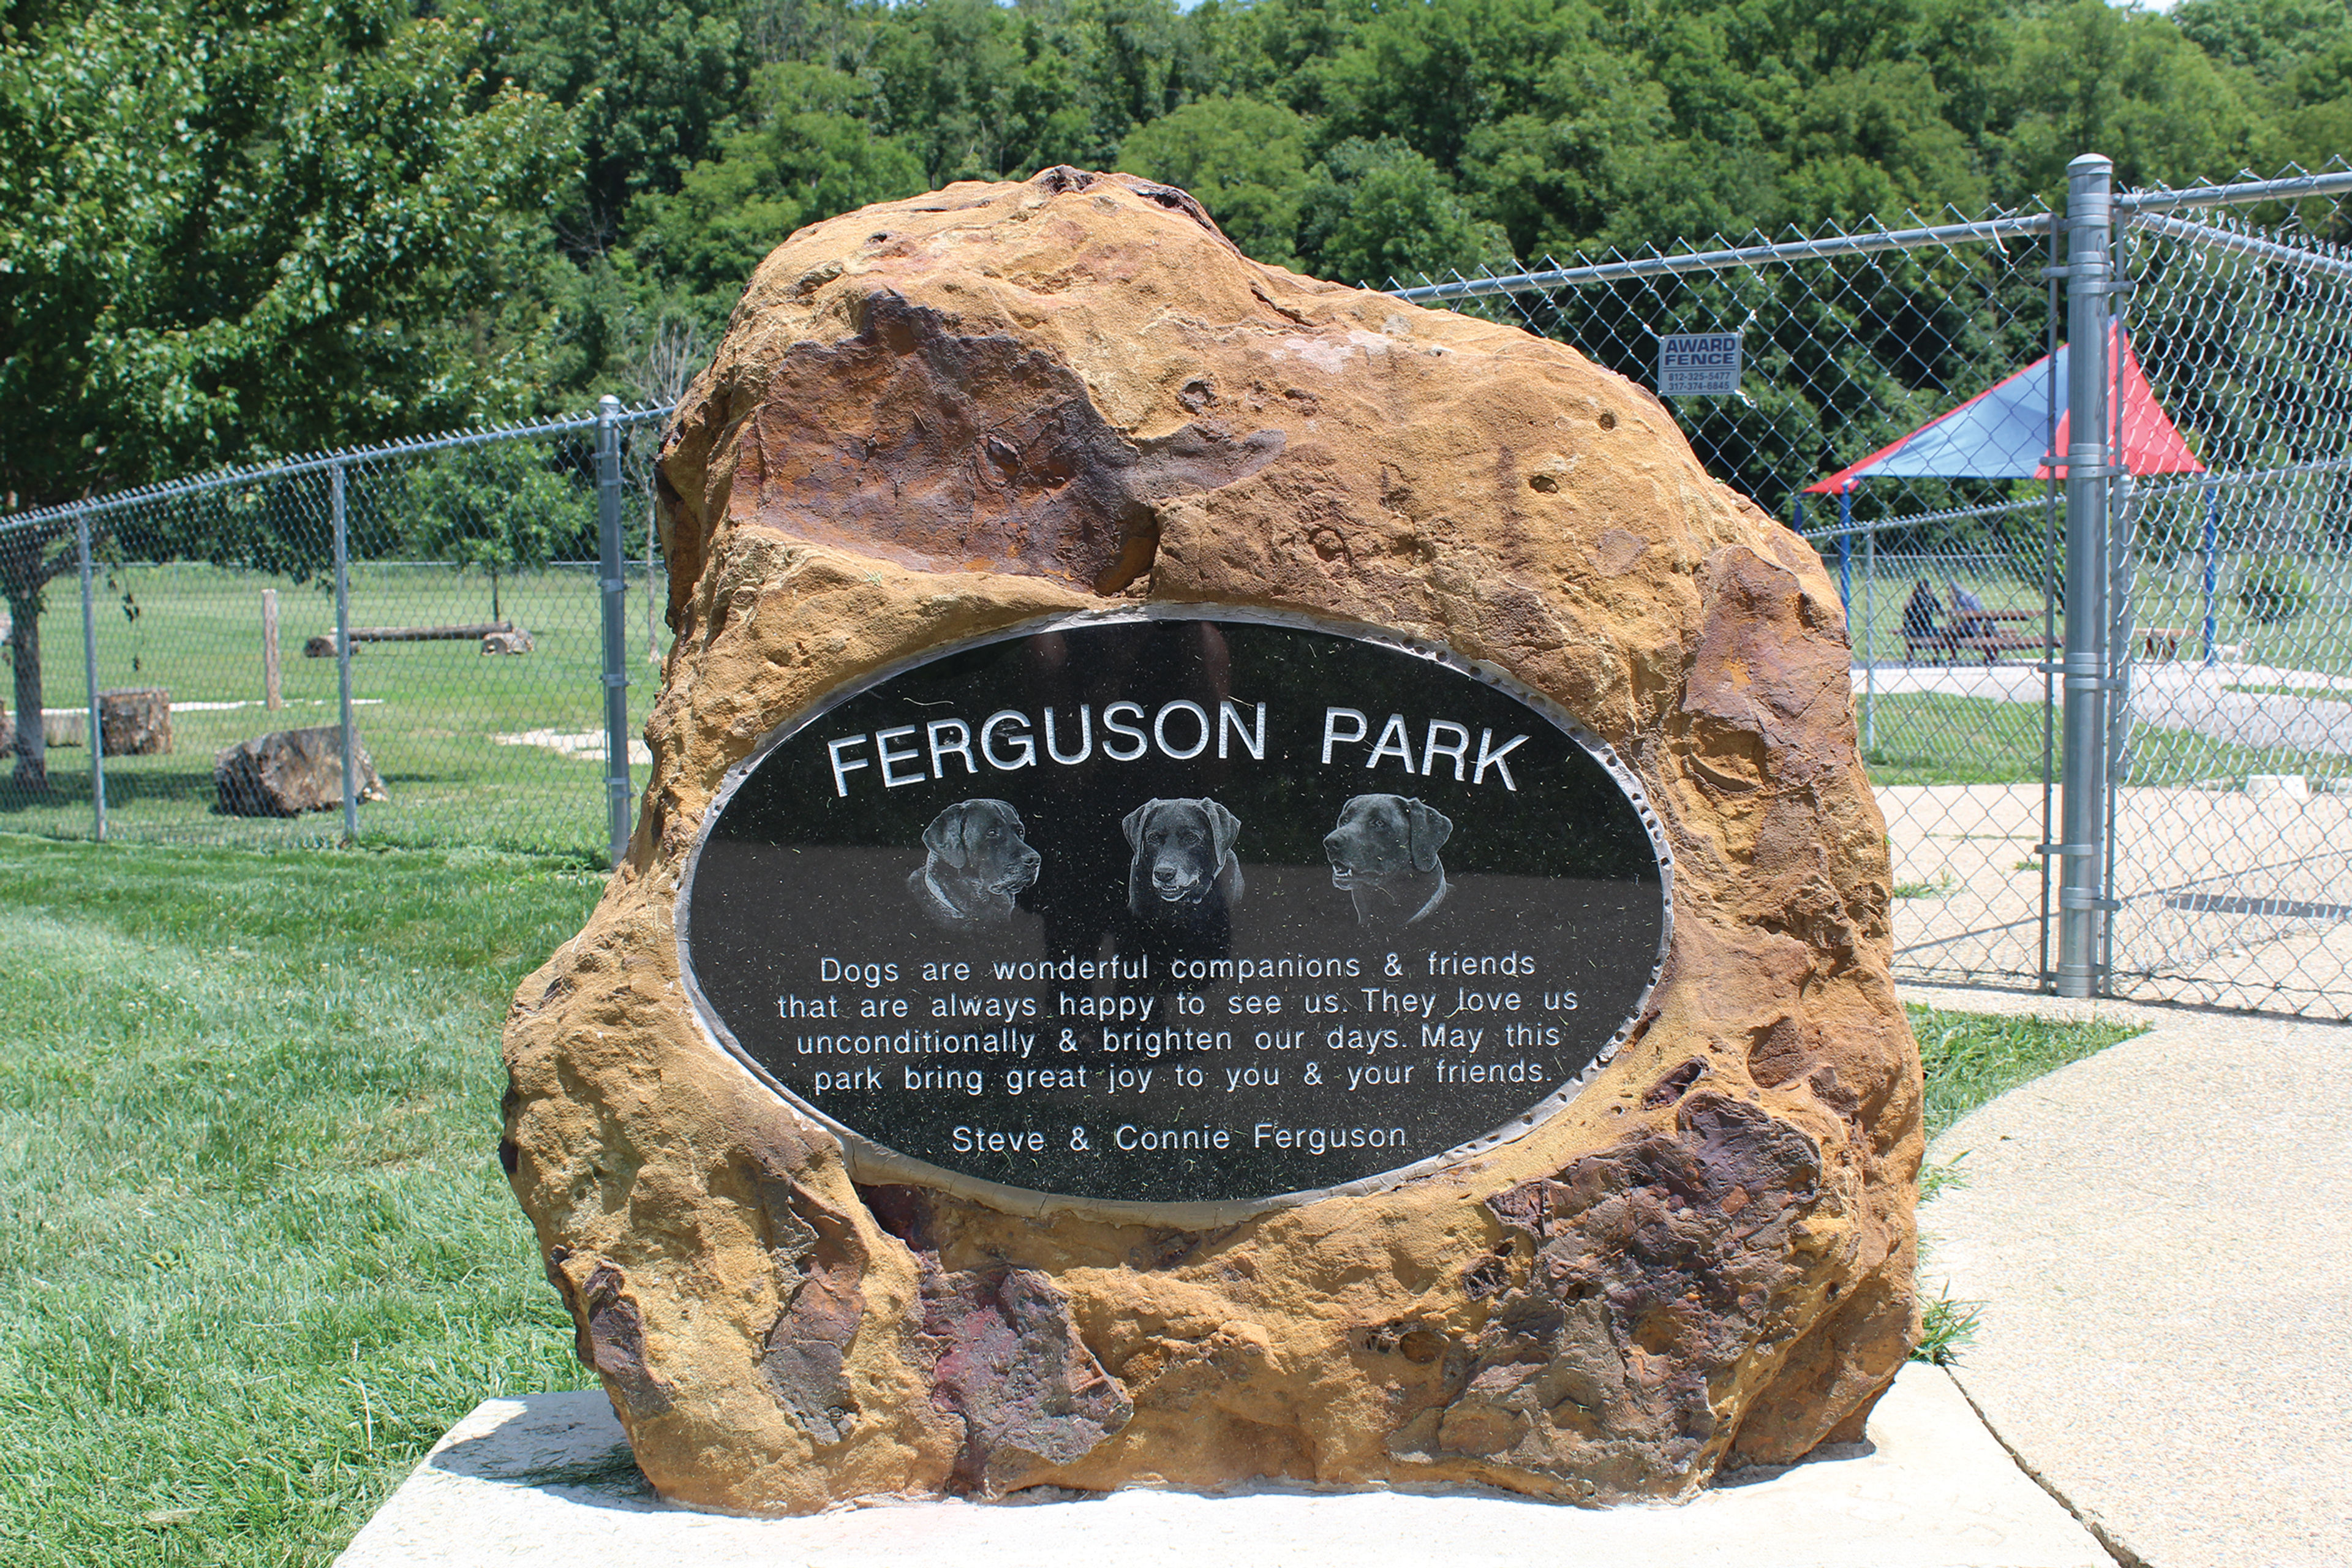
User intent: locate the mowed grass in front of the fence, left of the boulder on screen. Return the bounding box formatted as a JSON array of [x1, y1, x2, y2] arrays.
[[0, 835, 605, 1566]]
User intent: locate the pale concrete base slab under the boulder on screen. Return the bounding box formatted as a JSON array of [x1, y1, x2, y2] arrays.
[[339, 1366, 2112, 1568]]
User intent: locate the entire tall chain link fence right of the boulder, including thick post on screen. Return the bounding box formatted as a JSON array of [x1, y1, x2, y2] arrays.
[[1395, 157, 2352, 1016]]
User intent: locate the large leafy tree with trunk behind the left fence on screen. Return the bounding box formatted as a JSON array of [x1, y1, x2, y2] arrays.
[[0, 0, 571, 788]]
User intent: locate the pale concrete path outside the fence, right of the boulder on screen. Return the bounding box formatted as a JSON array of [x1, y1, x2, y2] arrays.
[[1905, 987, 2352, 1568]]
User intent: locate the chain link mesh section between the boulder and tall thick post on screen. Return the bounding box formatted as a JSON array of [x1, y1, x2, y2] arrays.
[[1400, 211, 2053, 1001]]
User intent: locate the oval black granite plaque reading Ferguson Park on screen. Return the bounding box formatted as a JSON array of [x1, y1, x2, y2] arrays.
[[680, 614, 1668, 1206]]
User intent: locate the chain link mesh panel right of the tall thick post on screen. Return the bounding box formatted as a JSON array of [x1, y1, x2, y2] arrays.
[[2108, 195, 2352, 1016]]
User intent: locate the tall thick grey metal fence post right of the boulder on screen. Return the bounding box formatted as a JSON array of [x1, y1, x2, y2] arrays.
[[2056, 153, 2114, 997]]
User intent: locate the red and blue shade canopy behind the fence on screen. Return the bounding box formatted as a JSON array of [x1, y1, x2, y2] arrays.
[[1804, 326, 2204, 496]]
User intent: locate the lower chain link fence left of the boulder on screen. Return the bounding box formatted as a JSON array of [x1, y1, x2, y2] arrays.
[[0, 407, 666, 853]]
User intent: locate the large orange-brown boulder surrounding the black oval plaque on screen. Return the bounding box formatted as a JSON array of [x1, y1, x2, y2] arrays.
[[501, 169, 1921, 1512]]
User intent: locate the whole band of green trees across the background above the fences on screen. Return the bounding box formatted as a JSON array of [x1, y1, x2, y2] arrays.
[[0, 0, 2352, 508]]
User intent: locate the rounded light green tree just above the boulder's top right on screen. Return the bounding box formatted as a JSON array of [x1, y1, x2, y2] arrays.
[[1120, 99, 1308, 266]]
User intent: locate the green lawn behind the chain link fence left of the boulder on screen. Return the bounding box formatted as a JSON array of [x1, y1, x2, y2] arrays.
[[0, 562, 666, 853]]
